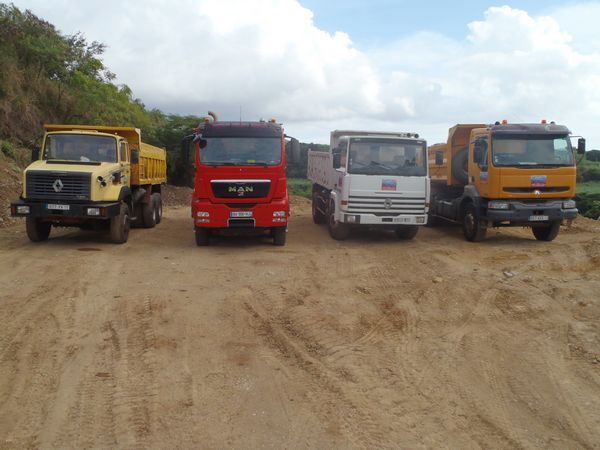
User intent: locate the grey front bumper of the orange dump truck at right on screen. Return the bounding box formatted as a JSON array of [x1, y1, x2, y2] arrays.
[[485, 200, 578, 224]]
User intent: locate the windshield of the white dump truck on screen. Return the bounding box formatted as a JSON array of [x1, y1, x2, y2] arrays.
[[342, 138, 427, 177]]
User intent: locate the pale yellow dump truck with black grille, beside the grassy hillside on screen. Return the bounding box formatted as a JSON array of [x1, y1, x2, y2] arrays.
[[11, 125, 167, 244]]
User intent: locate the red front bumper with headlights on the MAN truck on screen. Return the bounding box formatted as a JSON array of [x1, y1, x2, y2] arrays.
[[192, 199, 289, 228]]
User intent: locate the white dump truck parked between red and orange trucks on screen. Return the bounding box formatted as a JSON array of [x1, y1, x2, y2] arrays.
[[308, 130, 429, 240]]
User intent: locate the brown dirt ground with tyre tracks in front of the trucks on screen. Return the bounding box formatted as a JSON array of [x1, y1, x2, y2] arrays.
[[0, 199, 600, 449]]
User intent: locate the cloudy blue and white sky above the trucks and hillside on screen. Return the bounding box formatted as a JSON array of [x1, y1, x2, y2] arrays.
[[9, 0, 600, 149]]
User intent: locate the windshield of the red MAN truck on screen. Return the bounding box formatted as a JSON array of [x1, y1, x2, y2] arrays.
[[200, 137, 281, 166]]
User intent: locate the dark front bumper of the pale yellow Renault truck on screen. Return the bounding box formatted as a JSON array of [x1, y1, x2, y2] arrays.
[[10, 199, 121, 222]]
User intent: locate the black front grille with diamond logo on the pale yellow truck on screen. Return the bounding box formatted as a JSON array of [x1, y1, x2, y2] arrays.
[[26, 170, 91, 200]]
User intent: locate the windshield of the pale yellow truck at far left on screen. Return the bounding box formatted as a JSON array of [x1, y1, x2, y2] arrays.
[[44, 134, 117, 162]]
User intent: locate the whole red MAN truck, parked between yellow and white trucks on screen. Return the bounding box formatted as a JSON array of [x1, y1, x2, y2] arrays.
[[183, 118, 289, 246]]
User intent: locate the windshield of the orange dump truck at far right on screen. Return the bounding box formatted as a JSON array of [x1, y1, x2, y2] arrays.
[[492, 136, 573, 167]]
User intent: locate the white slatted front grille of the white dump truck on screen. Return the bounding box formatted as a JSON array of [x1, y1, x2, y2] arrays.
[[348, 195, 425, 216]]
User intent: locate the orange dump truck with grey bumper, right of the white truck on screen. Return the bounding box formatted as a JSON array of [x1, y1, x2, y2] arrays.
[[428, 121, 585, 241]]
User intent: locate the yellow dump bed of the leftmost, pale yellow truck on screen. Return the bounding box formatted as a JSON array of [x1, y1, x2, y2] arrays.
[[44, 124, 167, 185]]
